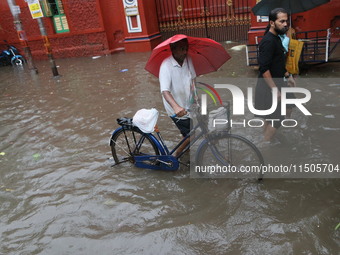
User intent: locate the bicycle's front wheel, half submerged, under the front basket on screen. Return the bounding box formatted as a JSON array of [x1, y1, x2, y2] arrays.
[[196, 133, 264, 180]]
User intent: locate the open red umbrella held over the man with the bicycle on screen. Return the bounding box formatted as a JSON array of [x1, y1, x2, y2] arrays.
[[145, 34, 231, 77]]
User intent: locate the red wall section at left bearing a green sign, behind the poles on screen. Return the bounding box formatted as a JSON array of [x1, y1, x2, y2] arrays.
[[0, 0, 109, 59]]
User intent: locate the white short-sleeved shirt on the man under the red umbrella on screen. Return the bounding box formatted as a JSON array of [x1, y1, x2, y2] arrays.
[[159, 55, 196, 116]]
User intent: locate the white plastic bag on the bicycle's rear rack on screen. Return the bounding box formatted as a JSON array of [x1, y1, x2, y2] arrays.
[[132, 108, 158, 133]]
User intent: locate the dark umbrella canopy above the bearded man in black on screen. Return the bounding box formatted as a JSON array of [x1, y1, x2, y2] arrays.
[[252, 0, 330, 16]]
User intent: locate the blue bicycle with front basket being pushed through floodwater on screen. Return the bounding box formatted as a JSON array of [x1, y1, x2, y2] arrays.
[[110, 103, 264, 180]]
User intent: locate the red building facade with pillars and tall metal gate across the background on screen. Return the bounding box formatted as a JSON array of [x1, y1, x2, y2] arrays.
[[0, 0, 340, 59]]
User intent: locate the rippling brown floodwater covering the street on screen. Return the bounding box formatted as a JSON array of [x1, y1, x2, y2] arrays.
[[0, 45, 340, 255]]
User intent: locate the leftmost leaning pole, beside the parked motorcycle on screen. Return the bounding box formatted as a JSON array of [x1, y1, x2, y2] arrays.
[[7, 0, 38, 73]]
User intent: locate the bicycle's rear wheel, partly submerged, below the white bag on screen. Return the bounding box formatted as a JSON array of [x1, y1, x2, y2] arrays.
[[110, 127, 159, 164]]
